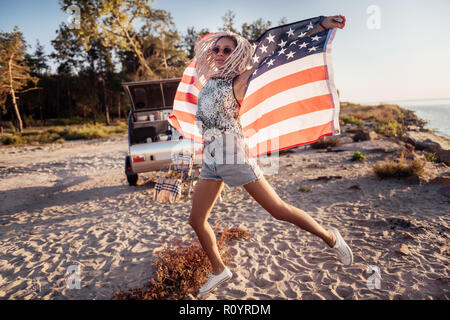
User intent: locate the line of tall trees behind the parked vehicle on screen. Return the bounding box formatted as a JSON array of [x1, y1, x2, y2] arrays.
[[0, 0, 286, 132]]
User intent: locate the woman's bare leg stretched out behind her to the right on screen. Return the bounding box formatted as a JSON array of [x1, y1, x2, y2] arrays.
[[244, 176, 336, 247]]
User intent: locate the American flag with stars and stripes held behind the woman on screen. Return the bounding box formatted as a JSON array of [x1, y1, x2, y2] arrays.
[[170, 16, 340, 157]]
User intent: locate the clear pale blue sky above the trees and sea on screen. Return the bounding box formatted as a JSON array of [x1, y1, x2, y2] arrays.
[[0, 0, 450, 102]]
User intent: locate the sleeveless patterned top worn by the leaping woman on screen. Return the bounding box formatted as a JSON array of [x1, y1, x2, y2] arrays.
[[196, 78, 243, 137]]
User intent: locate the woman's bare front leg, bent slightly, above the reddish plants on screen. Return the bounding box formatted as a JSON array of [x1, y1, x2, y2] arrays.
[[189, 179, 225, 274]]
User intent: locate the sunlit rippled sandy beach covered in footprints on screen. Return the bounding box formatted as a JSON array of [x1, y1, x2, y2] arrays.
[[0, 127, 450, 300]]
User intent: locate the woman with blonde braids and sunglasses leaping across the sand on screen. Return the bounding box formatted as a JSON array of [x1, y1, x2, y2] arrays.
[[189, 15, 353, 294]]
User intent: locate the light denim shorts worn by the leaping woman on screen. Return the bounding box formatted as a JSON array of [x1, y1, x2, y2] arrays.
[[199, 132, 263, 187]]
